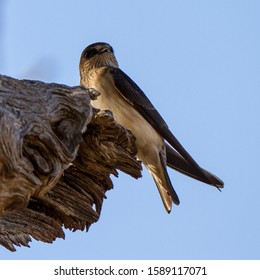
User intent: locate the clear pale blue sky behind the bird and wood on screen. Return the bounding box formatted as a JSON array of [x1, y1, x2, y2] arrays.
[[0, 0, 260, 259]]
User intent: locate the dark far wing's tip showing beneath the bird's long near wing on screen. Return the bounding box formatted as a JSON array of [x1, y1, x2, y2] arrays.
[[165, 143, 224, 189]]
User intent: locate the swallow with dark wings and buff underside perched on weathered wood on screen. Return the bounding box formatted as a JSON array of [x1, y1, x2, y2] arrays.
[[79, 42, 224, 213]]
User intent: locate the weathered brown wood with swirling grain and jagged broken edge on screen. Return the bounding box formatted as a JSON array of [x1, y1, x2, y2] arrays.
[[0, 76, 141, 251]]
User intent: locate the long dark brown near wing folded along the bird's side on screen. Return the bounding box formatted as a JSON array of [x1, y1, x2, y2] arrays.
[[107, 67, 219, 185]]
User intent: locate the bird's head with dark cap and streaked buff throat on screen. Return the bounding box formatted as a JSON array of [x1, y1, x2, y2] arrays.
[[80, 42, 118, 75]]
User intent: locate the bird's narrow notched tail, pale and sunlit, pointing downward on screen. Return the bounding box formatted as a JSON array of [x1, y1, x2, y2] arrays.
[[145, 153, 180, 213]]
